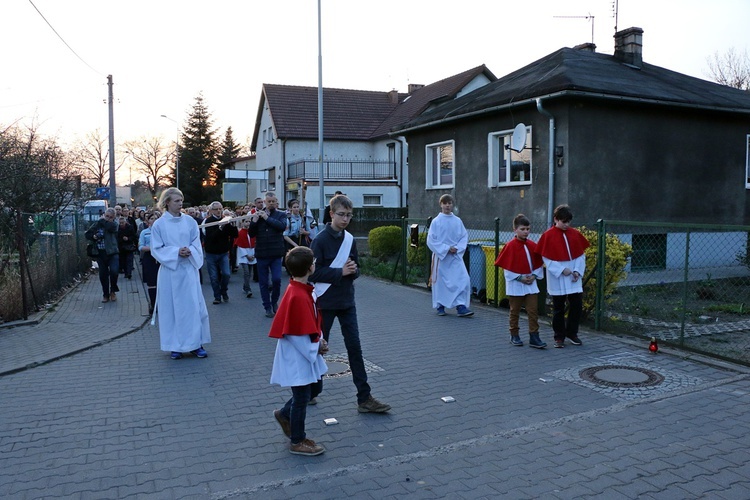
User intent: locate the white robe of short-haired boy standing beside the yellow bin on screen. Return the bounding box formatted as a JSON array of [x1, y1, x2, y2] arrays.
[[427, 213, 471, 308]]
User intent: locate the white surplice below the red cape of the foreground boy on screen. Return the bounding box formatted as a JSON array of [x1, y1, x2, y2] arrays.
[[271, 335, 328, 387]]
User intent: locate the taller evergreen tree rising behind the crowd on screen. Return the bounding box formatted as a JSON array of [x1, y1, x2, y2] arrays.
[[179, 94, 221, 205]]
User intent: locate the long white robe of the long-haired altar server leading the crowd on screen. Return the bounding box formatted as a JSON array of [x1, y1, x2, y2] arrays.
[[151, 212, 211, 352]]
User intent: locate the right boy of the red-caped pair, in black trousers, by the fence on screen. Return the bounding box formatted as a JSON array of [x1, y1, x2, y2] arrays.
[[536, 205, 589, 348]]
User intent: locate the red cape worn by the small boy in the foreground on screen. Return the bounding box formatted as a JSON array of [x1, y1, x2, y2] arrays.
[[268, 280, 322, 342]]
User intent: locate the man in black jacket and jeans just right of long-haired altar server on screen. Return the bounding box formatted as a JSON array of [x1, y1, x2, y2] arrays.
[[204, 201, 238, 304]]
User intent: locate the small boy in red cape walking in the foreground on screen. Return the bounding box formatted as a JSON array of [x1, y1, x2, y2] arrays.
[[268, 247, 328, 456]]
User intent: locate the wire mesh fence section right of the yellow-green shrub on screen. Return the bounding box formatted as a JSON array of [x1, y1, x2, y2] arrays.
[[596, 221, 750, 364]]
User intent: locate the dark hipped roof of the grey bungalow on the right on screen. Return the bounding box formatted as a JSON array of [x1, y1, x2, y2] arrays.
[[396, 48, 750, 130]]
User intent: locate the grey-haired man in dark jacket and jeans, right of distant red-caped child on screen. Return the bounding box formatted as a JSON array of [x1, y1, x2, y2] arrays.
[[247, 192, 286, 318]]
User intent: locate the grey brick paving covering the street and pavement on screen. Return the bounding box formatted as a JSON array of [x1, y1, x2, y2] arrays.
[[0, 268, 750, 499]]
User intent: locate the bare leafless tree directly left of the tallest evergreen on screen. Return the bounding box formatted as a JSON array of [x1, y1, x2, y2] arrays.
[[125, 137, 175, 201]]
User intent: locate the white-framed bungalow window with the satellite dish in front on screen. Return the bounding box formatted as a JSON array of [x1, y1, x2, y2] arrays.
[[487, 127, 532, 187]]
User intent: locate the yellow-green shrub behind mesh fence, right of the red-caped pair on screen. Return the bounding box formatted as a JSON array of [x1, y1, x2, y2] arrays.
[[579, 227, 633, 318]]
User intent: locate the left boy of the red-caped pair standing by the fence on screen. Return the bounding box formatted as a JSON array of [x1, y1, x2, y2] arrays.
[[495, 214, 547, 349]]
